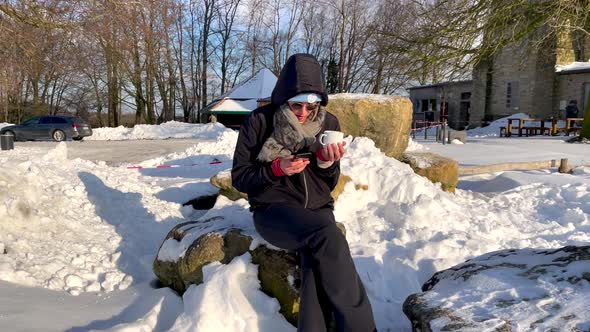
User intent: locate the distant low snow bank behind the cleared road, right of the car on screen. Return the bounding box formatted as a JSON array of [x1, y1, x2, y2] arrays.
[[84, 121, 231, 141]]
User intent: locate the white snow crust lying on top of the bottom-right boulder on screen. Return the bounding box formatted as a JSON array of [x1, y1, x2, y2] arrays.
[[425, 249, 590, 331]]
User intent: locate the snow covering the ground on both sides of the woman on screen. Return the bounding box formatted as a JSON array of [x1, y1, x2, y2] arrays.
[[0, 118, 590, 331]]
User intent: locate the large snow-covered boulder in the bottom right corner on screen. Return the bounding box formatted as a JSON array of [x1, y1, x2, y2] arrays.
[[403, 246, 590, 332]]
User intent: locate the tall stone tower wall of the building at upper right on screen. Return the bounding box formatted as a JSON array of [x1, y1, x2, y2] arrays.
[[470, 28, 590, 125]]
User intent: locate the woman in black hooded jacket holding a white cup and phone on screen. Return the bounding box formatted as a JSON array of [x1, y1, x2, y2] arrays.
[[232, 54, 375, 332]]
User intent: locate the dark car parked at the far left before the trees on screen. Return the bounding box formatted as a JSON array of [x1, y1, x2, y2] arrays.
[[0, 115, 92, 142]]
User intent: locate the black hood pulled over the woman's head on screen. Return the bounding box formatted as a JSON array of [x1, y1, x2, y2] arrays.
[[271, 53, 328, 106]]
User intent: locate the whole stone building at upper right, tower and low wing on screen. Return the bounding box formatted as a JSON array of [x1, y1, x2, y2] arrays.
[[410, 27, 590, 129]]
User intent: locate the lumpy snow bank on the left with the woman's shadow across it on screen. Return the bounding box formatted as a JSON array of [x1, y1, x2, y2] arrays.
[[0, 142, 182, 295]]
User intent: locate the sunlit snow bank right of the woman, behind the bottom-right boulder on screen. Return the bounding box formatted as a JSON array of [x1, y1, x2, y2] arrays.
[[335, 138, 590, 330]]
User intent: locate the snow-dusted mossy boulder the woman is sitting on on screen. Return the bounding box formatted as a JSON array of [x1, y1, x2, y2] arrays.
[[153, 216, 346, 326]]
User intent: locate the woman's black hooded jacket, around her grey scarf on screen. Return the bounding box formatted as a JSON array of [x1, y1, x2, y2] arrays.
[[231, 54, 340, 210]]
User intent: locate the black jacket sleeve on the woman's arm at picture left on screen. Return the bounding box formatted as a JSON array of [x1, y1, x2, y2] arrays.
[[231, 113, 279, 194]]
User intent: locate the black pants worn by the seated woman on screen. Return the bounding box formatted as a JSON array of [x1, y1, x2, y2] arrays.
[[254, 205, 375, 332]]
